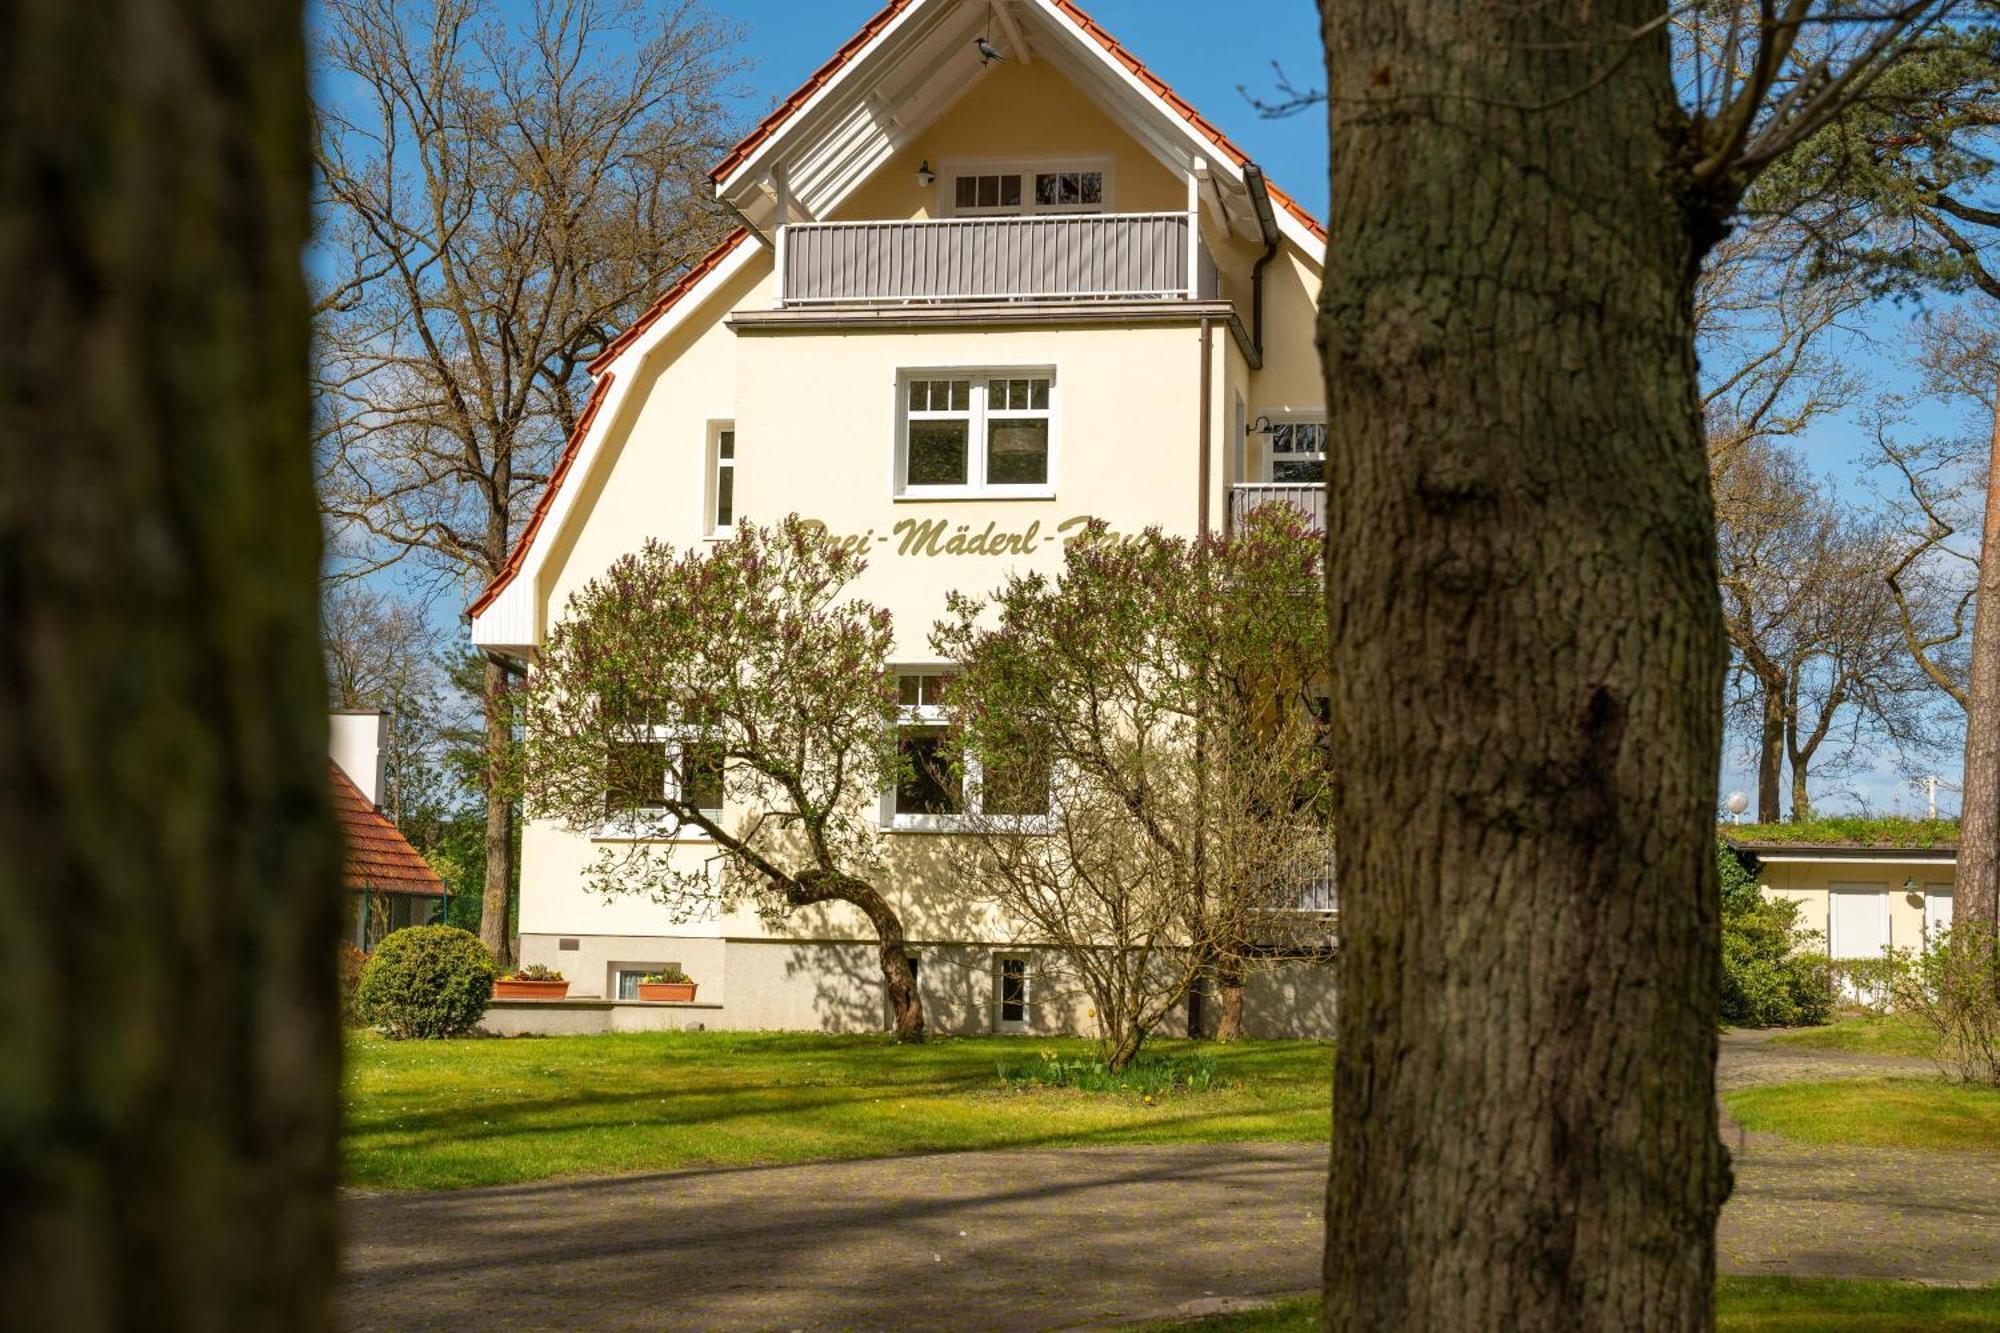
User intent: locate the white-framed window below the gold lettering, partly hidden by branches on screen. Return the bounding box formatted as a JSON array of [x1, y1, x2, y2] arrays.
[[884, 669, 1050, 831]]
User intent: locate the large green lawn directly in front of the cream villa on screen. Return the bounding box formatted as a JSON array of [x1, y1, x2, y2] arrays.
[[344, 1033, 1332, 1189]]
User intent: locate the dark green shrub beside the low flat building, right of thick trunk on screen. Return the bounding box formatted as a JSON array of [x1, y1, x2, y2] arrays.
[[1716, 847, 1834, 1027]]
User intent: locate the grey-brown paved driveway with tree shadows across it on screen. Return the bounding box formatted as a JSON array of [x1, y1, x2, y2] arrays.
[[344, 1047, 2000, 1329]]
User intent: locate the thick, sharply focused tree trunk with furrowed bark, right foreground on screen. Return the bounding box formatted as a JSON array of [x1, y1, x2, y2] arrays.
[[1320, 0, 1730, 1333]]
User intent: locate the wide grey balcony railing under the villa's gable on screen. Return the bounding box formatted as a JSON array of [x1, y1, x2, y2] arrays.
[[778, 212, 1220, 306]]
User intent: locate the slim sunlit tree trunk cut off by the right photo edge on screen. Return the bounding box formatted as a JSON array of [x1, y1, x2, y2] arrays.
[[1952, 390, 2000, 927]]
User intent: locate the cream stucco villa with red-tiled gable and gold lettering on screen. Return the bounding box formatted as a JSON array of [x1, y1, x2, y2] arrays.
[[472, 0, 1330, 1035]]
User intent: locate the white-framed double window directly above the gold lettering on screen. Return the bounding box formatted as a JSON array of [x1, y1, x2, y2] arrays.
[[896, 370, 1056, 498]]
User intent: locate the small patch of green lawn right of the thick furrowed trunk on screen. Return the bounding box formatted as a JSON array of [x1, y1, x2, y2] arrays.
[[1726, 1079, 2000, 1153]]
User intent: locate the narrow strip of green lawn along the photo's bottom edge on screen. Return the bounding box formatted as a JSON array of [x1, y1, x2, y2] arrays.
[[1156, 1277, 2000, 1333]]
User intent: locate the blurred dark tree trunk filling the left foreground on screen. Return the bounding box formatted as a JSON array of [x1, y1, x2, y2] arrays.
[[0, 0, 340, 1331]]
